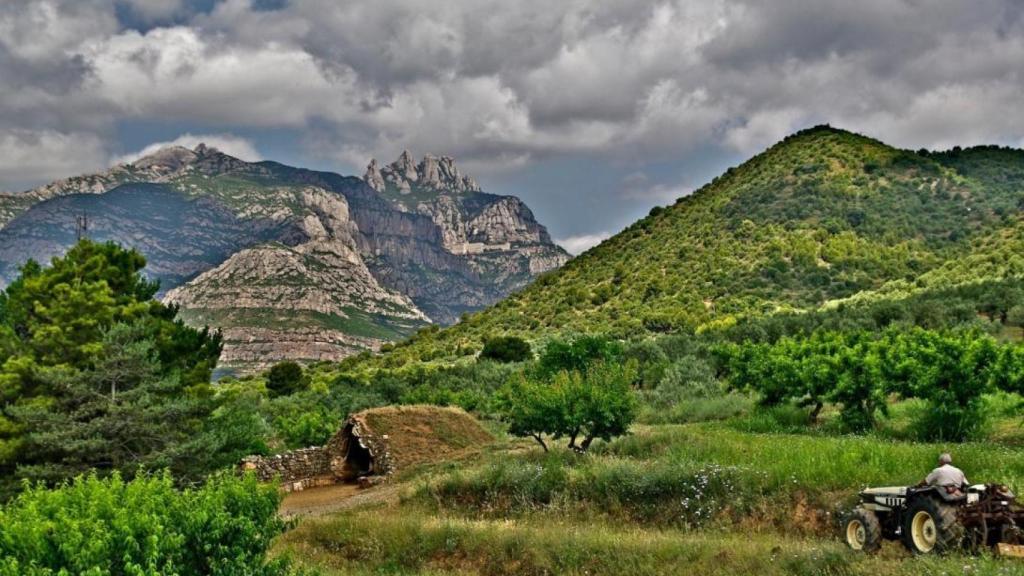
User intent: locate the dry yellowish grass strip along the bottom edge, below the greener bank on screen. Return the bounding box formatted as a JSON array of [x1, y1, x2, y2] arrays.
[[276, 504, 1021, 576]]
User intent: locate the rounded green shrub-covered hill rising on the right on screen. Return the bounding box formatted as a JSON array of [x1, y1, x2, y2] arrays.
[[372, 126, 1024, 360]]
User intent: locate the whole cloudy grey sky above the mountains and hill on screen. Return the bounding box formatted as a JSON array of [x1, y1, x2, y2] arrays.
[[0, 0, 1024, 253]]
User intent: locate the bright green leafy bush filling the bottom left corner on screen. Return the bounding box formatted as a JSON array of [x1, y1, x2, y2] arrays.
[[0, 474, 286, 576]]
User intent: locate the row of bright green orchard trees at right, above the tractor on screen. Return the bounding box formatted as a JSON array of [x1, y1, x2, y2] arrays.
[[717, 328, 1024, 440]]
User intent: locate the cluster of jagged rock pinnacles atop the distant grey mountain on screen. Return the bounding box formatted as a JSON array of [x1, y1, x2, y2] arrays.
[[362, 150, 480, 194]]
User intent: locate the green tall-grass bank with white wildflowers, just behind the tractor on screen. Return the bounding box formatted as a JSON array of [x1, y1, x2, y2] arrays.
[[415, 423, 1024, 532]]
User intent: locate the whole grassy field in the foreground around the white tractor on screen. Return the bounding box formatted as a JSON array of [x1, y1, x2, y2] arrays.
[[276, 412, 1024, 575]]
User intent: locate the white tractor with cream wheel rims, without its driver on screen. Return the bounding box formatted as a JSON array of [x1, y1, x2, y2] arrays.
[[843, 484, 1024, 558]]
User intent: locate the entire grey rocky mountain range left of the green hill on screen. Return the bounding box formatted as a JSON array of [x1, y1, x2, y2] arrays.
[[0, 145, 569, 370]]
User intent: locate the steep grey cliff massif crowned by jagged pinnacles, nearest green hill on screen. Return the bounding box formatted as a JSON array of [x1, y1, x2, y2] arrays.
[[357, 151, 569, 324]]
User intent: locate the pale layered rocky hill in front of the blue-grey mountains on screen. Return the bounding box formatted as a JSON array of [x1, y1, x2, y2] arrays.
[[165, 188, 430, 369]]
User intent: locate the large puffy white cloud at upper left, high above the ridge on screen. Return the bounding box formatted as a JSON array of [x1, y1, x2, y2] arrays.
[[85, 27, 359, 126]]
